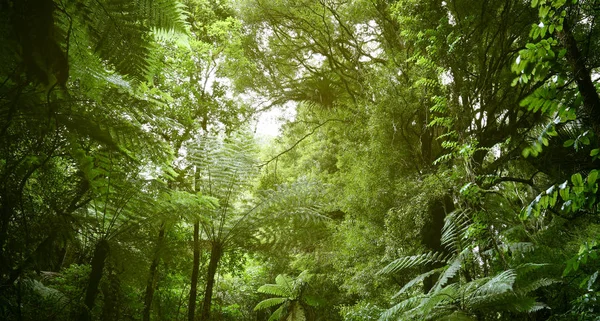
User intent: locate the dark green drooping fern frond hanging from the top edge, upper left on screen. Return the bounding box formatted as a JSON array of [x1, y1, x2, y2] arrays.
[[62, 0, 188, 80]]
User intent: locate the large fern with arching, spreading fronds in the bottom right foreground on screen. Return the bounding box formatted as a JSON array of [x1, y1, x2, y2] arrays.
[[379, 202, 556, 320]]
